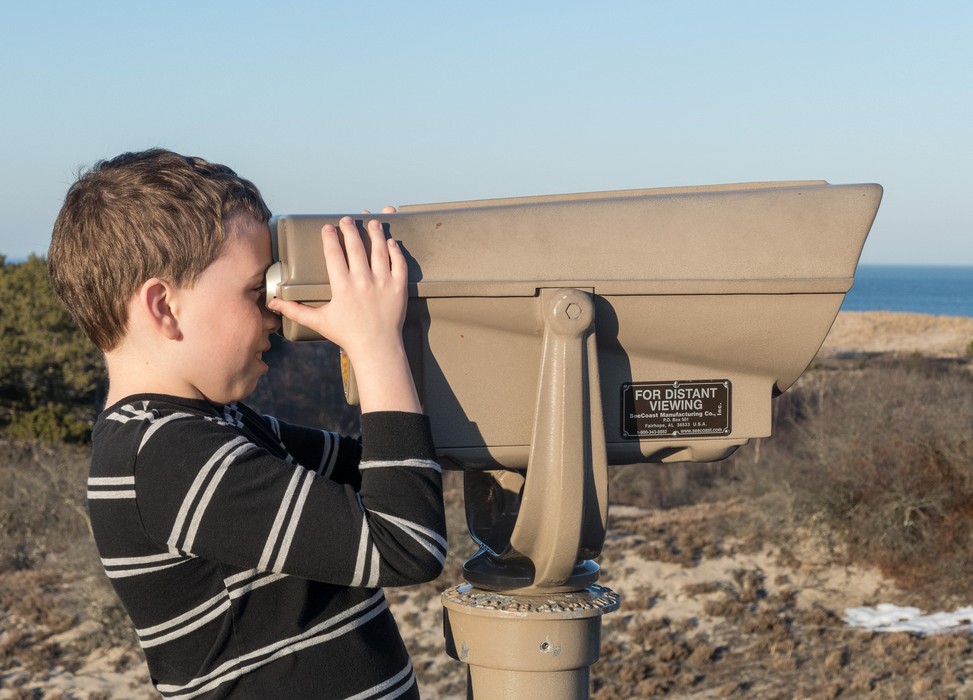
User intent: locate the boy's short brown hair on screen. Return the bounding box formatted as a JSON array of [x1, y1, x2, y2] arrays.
[[47, 149, 270, 352]]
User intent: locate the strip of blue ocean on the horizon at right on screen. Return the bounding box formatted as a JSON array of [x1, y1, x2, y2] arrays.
[[841, 265, 973, 317]]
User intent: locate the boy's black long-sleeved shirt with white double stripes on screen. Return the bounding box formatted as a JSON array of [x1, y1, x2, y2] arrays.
[[88, 395, 446, 700]]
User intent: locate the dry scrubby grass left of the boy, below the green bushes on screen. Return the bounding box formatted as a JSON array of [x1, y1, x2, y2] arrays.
[[0, 442, 142, 698]]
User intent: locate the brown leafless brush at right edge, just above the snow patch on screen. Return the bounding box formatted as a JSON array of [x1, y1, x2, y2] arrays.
[[739, 356, 973, 595]]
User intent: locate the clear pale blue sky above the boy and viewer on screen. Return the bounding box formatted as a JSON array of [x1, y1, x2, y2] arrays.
[[0, 0, 973, 265]]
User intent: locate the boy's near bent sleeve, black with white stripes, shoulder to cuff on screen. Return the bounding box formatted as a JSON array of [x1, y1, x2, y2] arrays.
[[133, 411, 446, 587]]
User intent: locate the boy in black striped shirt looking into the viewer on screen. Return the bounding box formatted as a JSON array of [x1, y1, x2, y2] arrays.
[[48, 150, 446, 700]]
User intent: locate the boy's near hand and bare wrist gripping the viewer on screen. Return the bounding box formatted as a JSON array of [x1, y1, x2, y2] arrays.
[[268, 208, 421, 412]]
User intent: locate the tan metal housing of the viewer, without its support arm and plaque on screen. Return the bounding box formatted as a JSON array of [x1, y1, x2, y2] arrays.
[[270, 182, 881, 469]]
